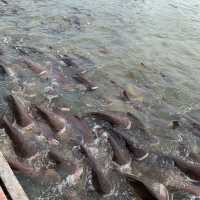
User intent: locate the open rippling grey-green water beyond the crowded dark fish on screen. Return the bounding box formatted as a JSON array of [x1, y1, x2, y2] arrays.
[[0, 0, 200, 199]]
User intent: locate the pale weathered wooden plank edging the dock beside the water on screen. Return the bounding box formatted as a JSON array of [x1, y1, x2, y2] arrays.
[[0, 152, 28, 200]]
